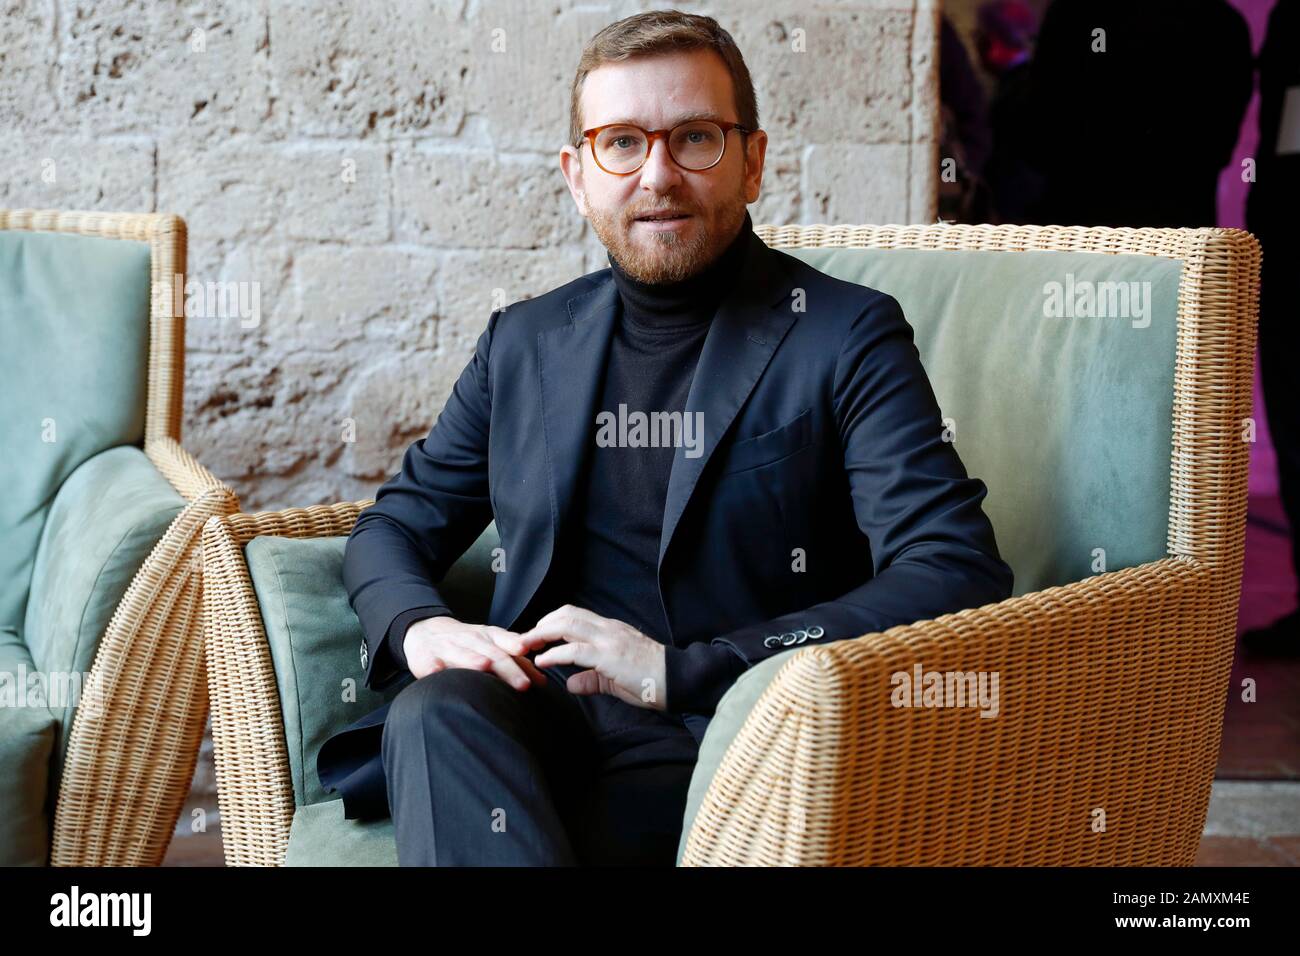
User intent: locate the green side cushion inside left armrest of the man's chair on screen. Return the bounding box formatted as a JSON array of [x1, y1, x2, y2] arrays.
[[244, 524, 498, 823]]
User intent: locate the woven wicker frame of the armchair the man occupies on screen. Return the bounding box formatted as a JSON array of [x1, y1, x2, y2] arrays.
[[204, 224, 1260, 866]]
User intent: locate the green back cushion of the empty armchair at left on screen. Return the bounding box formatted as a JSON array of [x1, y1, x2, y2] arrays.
[[0, 230, 150, 633]]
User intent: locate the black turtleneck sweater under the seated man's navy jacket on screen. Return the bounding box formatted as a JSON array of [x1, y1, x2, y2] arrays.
[[384, 211, 753, 714]]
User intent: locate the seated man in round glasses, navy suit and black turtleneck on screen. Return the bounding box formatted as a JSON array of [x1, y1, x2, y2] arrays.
[[317, 12, 1011, 865]]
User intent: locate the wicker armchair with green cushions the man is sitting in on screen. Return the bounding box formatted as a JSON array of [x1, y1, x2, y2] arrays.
[[204, 224, 1260, 865]]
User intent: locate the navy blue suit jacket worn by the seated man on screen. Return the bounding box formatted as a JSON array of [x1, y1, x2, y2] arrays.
[[317, 233, 1011, 818]]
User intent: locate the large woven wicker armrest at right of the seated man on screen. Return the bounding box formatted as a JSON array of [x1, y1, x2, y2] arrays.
[[683, 558, 1232, 866]]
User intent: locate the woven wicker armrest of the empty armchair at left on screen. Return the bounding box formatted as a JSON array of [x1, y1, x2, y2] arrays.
[[51, 437, 239, 866]]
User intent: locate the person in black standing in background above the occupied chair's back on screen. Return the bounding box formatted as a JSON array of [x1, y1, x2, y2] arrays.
[[1021, 0, 1252, 226]]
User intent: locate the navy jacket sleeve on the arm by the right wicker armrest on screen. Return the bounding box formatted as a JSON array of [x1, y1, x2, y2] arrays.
[[712, 294, 1013, 676]]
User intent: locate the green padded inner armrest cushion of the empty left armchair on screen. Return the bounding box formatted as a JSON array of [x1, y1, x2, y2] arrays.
[[22, 445, 185, 782]]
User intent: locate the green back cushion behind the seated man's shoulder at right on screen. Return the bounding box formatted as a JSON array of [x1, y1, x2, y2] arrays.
[[784, 248, 1182, 594]]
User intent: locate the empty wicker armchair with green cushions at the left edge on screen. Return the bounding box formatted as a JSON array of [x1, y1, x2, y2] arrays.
[[0, 209, 238, 865]]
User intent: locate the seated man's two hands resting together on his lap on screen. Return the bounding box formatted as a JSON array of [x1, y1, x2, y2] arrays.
[[402, 605, 667, 710]]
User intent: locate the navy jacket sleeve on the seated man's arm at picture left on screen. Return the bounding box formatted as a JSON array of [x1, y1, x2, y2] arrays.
[[343, 311, 501, 689]]
